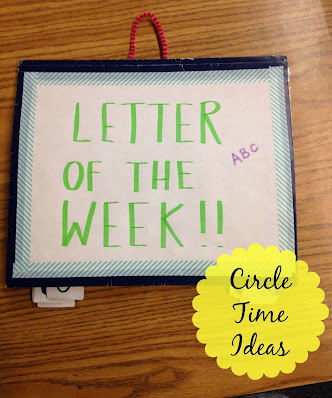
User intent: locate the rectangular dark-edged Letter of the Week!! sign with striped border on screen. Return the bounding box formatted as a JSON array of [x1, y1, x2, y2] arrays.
[[7, 56, 296, 286]]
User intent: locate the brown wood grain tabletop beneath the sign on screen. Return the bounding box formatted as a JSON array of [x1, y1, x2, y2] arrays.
[[0, 0, 332, 398]]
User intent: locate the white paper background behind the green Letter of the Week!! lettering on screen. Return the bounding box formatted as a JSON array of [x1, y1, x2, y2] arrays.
[[31, 83, 279, 268]]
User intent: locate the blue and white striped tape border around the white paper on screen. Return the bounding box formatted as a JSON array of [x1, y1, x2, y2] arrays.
[[13, 66, 295, 278]]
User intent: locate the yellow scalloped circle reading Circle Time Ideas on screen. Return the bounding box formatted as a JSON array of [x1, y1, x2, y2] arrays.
[[192, 244, 329, 380]]
